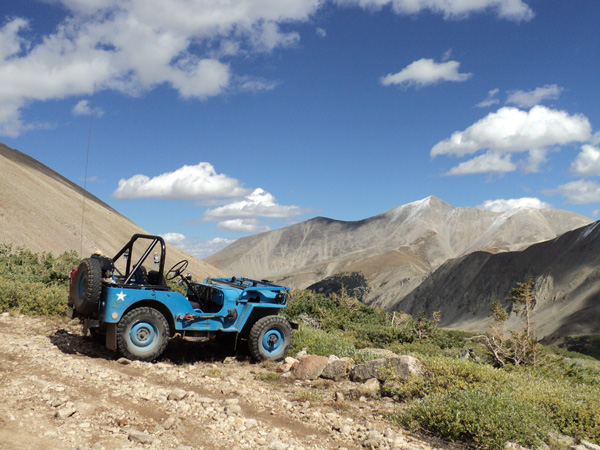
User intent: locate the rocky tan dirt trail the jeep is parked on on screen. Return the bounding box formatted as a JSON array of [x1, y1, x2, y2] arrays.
[[0, 313, 462, 450]]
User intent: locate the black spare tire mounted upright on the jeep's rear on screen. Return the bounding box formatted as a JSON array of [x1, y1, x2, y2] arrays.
[[73, 258, 102, 315]]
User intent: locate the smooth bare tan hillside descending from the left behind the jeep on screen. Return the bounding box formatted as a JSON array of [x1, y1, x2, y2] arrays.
[[0, 143, 224, 279]]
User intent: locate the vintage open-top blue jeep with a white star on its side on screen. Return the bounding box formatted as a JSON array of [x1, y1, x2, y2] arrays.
[[68, 234, 295, 361]]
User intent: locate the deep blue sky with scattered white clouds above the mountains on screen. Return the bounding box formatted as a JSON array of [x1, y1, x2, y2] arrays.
[[0, 0, 600, 257]]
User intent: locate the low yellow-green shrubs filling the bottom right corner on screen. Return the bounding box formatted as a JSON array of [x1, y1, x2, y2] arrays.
[[384, 356, 600, 448]]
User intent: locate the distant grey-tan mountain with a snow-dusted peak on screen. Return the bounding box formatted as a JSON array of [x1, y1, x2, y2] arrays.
[[205, 196, 591, 309]]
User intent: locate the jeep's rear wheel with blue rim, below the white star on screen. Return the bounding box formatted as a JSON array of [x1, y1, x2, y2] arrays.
[[117, 307, 170, 361]]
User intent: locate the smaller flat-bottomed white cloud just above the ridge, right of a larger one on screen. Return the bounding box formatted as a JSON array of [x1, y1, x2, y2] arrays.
[[203, 188, 308, 223]]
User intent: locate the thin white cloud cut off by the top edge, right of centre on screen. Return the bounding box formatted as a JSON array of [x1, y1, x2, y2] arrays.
[[336, 0, 534, 22]]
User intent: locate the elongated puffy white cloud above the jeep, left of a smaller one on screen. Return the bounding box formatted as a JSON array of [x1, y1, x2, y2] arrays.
[[113, 162, 248, 200]]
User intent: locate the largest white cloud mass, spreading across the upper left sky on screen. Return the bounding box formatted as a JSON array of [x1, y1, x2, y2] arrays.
[[0, 0, 321, 136]]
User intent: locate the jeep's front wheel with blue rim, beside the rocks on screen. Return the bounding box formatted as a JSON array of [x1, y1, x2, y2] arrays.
[[248, 316, 293, 361]]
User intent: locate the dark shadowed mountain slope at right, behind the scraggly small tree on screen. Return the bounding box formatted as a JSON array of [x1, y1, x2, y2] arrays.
[[398, 222, 600, 342]]
